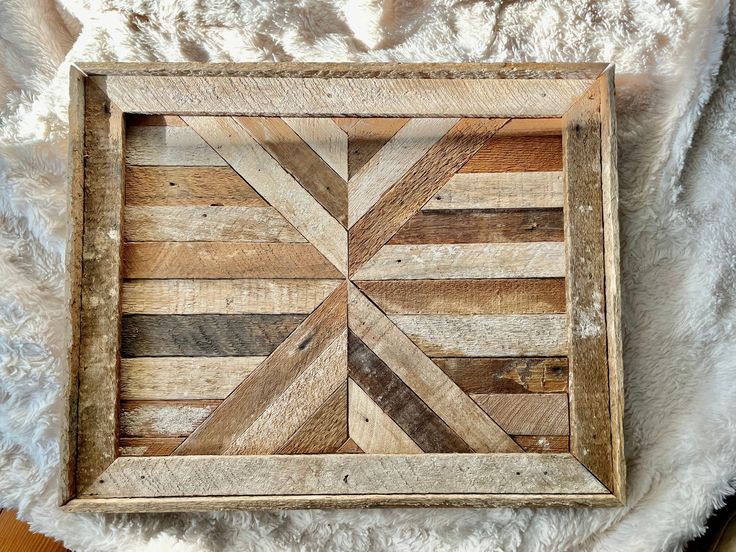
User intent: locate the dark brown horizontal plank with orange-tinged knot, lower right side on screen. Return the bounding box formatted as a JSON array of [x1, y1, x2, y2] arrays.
[[432, 357, 568, 393]]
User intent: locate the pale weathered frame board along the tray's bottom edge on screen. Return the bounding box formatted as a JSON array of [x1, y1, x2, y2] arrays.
[[85, 453, 606, 498]]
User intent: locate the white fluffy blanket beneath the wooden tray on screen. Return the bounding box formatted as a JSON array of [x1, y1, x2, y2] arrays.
[[0, 0, 736, 551]]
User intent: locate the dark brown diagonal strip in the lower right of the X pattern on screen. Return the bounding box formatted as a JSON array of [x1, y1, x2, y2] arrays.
[[348, 332, 473, 452]]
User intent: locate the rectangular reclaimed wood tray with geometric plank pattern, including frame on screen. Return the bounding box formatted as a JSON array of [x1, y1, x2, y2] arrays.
[[62, 64, 624, 511]]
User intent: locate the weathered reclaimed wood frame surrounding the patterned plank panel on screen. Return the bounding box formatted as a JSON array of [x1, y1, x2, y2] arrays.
[[60, 63, 625, 512]]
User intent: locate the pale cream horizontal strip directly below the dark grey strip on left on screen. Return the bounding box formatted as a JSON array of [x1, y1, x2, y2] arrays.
[[120, 356, 266, 400]]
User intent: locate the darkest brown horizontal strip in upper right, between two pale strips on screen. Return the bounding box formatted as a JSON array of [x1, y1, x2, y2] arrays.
[[388, 209, 564, 245]]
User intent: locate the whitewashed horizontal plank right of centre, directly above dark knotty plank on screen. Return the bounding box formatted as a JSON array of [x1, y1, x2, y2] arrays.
[[389, 314, 568, 357]]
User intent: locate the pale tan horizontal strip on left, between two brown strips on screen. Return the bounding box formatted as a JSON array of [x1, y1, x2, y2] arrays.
[[123, 205, 307, 242]]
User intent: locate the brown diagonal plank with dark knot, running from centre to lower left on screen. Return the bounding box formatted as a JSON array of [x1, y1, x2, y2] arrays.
[[175, 284, 347, 455]]
